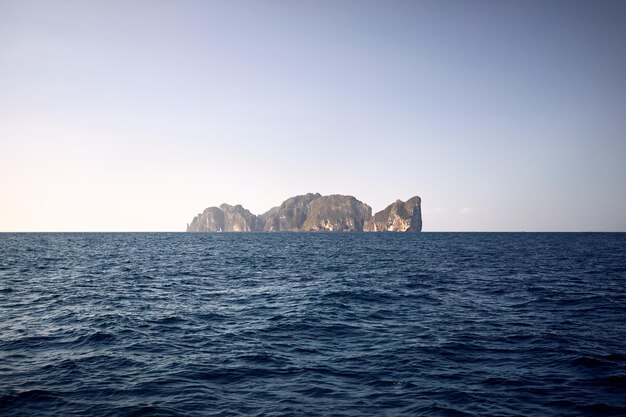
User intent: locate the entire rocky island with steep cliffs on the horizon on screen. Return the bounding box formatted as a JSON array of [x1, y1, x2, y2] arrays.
[[187, 193, 422, 232]]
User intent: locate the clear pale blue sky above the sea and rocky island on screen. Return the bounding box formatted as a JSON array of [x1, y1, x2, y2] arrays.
[[0, 0, 626, 231]]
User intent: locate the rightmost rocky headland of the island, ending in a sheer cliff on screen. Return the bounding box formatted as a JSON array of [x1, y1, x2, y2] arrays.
[[363, 196, 422, 232]]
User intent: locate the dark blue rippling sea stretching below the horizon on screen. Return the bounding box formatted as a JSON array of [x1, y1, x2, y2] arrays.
[[0, 233, 626, 416]]
